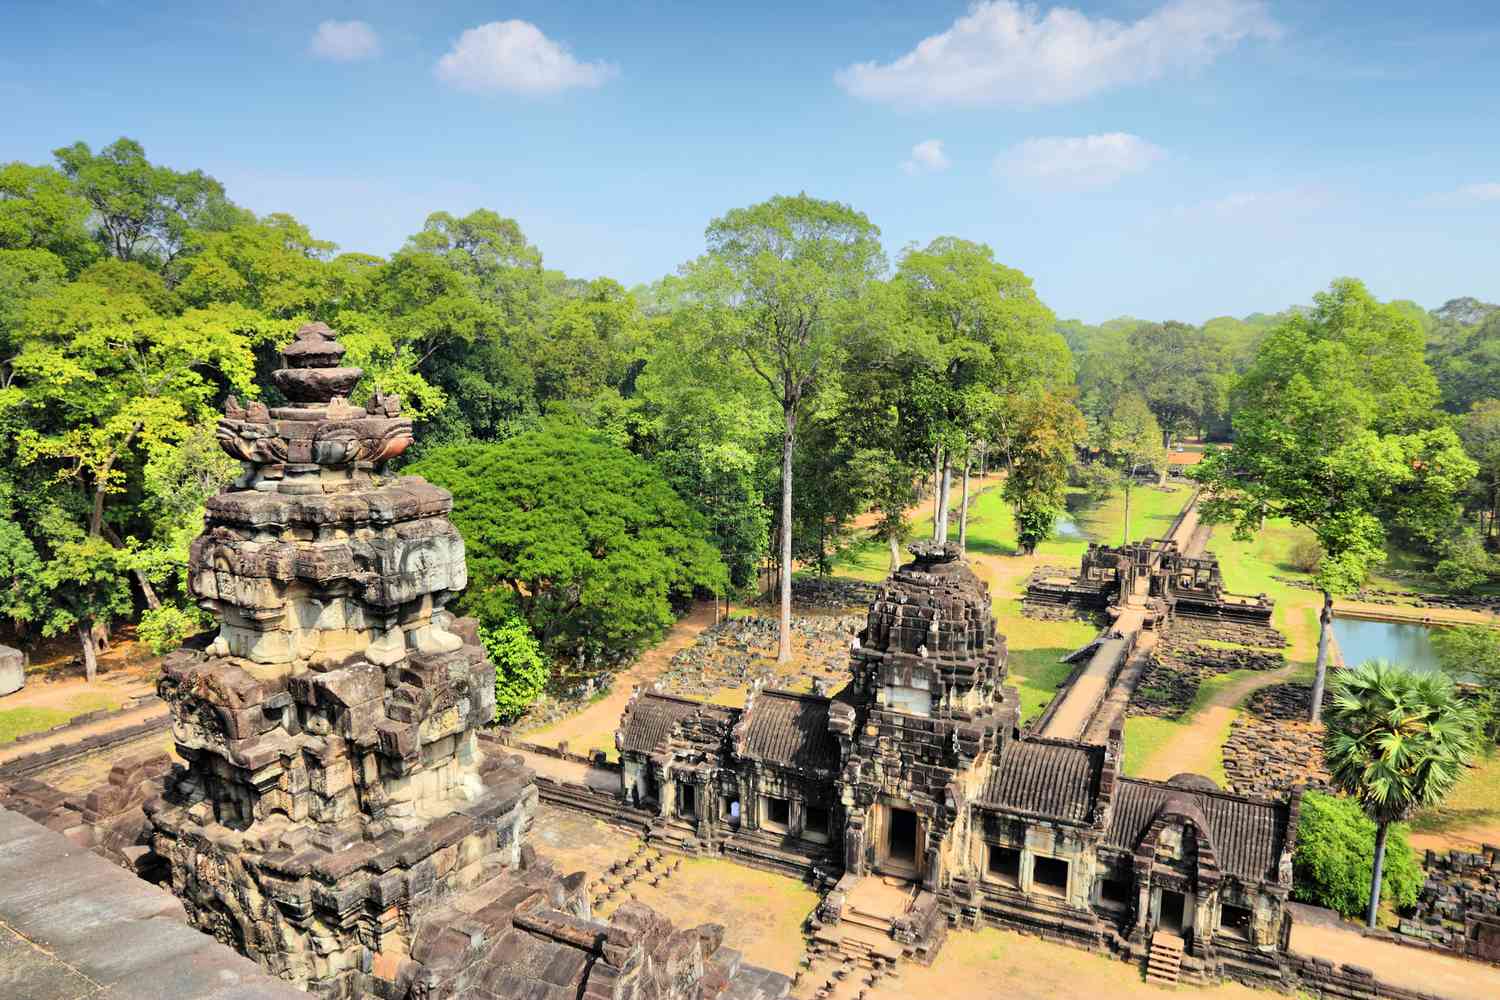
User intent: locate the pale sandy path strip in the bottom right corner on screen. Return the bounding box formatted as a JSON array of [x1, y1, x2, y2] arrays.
[[1292, 921, 1500, 1000]]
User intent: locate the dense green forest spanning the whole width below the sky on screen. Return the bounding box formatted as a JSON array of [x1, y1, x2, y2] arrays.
[[0, 139, 1500, 689]]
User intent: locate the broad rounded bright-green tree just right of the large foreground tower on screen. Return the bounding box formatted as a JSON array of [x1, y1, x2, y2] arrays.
[[411, 424, 728, 660]]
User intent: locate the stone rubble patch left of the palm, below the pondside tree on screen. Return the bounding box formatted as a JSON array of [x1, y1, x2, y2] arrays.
[[1224, 684, 1332, 798]]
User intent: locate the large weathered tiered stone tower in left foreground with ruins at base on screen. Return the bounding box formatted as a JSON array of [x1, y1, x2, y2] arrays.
[[135, 324, 788, 1000]]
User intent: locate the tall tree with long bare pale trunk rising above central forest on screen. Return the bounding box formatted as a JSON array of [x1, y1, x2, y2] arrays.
[[687, 195, 885, 663]]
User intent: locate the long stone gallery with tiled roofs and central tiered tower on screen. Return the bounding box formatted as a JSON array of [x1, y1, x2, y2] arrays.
[[617, 544, 1299, 984]]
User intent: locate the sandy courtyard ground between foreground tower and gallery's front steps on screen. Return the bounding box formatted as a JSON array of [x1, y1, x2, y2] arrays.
[[531, 804, 818, 975]]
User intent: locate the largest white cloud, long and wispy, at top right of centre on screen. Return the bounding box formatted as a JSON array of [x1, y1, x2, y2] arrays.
[[834, 0, 1281, 106]]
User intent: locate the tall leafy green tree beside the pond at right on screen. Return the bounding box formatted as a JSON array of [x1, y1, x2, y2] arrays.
[[1193, 279, 1476, 721]]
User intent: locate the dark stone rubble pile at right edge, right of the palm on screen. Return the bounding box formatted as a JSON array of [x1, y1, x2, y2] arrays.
[[1397, 844, 1500, 963]]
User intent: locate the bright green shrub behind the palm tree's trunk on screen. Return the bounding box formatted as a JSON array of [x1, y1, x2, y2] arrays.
[[1292, 792, 1422, 916]]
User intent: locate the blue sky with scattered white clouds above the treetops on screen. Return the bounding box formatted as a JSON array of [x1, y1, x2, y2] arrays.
[[0, 0, 1500, 321]]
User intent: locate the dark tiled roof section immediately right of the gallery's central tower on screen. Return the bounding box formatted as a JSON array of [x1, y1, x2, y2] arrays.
[[983, 739, 1104, 823]]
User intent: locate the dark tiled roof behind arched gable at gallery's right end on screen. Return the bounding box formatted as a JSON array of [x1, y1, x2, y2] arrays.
[[1104, 778, 1290, 882]]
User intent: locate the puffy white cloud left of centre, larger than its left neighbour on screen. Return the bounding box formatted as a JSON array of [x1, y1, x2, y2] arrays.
[[435, 21, 620, 94]]
